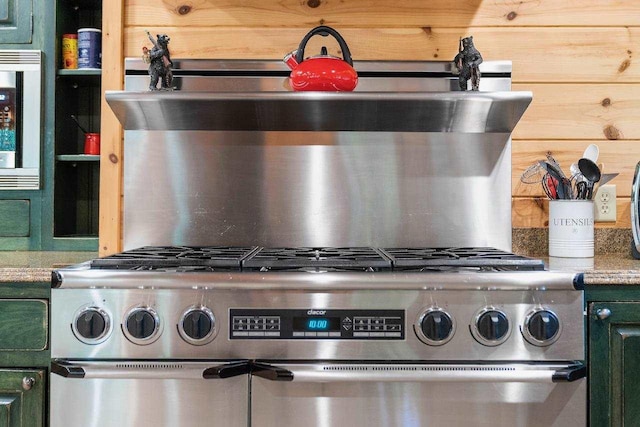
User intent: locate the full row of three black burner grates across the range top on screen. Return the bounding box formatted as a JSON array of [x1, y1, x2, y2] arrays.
[[91, 246, 544, 272]]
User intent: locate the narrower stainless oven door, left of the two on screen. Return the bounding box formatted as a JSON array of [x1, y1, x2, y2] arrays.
[[50, 360, 249, 427]]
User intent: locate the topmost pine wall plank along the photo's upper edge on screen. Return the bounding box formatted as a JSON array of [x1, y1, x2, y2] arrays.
[[126, 0, 640, 28]]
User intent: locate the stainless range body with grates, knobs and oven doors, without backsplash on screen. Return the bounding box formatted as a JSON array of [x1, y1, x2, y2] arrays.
[[50, 246, 586, 427]]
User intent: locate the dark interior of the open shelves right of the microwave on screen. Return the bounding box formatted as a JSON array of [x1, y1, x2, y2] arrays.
[[53, 0, 102, 244]]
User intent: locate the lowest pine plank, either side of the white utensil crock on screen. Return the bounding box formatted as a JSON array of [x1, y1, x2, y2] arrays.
[[511, 197, 631, 228]]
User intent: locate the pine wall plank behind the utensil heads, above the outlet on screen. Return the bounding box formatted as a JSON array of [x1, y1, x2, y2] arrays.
[[511, 140, 640, 197]]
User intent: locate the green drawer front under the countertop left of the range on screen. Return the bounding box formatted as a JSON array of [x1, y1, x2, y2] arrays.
[[0, 299, 49, 351]]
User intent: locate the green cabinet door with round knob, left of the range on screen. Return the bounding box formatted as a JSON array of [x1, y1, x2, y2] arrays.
[[0, 369, 45, 427]]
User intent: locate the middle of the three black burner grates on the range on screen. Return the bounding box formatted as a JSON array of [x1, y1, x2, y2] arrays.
[[242, 247, 391, 271]]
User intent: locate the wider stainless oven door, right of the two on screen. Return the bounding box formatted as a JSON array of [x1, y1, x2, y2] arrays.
[[251, 363, 587, 427]]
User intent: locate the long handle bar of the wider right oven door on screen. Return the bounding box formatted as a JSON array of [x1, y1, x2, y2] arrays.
[[252, 363, 587, 384]]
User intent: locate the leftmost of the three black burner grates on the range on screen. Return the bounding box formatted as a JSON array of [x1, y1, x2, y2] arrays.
[[91, 246, 258, 271]]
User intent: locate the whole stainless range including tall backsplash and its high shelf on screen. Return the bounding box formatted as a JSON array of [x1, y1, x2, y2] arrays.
[[50, 60, 586, 427]]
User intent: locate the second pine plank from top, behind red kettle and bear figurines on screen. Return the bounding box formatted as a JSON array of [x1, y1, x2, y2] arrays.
[[124, 24, 640, 83]]
